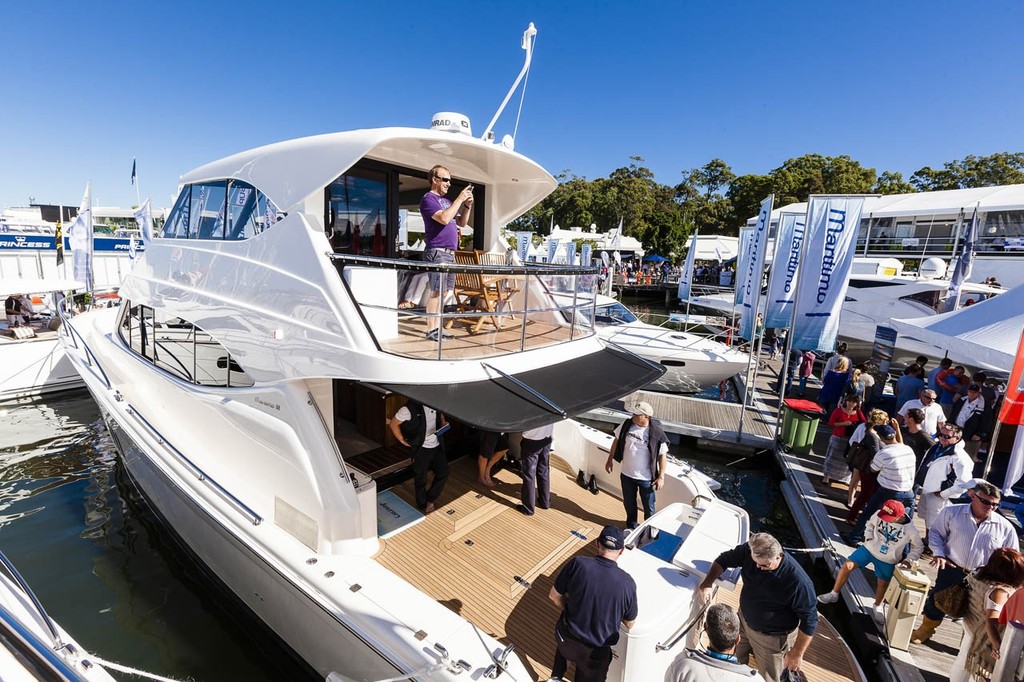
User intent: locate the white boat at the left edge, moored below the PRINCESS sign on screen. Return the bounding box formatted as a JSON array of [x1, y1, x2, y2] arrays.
[[0, 279, 85, 402]]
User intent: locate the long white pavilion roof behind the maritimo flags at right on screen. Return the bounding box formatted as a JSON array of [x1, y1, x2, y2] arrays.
[[761, 184, 1024, 223]]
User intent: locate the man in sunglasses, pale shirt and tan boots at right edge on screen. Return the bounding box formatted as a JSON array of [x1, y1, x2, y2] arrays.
[[910, 479, 1018, 644]]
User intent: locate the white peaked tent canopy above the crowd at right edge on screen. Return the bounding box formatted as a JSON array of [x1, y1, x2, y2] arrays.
[[891, 285, 1024, 374]]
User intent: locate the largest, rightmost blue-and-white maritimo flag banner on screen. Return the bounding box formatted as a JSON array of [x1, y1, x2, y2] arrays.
[[793, 192, 864, 351]]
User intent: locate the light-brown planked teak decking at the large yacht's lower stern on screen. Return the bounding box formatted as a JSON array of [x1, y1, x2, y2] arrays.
[[377, 448, 859, 681]]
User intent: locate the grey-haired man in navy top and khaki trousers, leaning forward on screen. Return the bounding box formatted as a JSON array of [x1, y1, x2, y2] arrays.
[[699, 532, 818, 682]]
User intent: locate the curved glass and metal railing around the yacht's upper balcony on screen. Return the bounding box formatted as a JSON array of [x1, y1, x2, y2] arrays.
[[332, 252, 598, 359]]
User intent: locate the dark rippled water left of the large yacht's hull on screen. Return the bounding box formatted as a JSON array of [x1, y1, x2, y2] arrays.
[[0, 393, 308, 680]]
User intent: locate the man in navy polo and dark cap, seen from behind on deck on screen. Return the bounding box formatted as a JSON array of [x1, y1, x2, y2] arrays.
[[548, 525, 634, 682]]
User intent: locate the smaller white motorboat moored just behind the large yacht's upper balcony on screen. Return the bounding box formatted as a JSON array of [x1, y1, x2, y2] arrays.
[[594, 296, 750, 393]]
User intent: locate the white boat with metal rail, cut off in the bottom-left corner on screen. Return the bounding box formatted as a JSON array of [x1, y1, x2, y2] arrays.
[[0, 553, 115, 682]]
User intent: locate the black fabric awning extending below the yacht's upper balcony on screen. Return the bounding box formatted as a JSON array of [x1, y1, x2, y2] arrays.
[[381, 347, 665, 431]]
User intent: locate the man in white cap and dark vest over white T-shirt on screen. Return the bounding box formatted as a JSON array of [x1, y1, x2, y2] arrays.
[[604, 401, 669, 529]]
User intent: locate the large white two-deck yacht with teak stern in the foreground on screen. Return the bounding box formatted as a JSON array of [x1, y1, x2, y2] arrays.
[[61, 35, 749, 681]]
